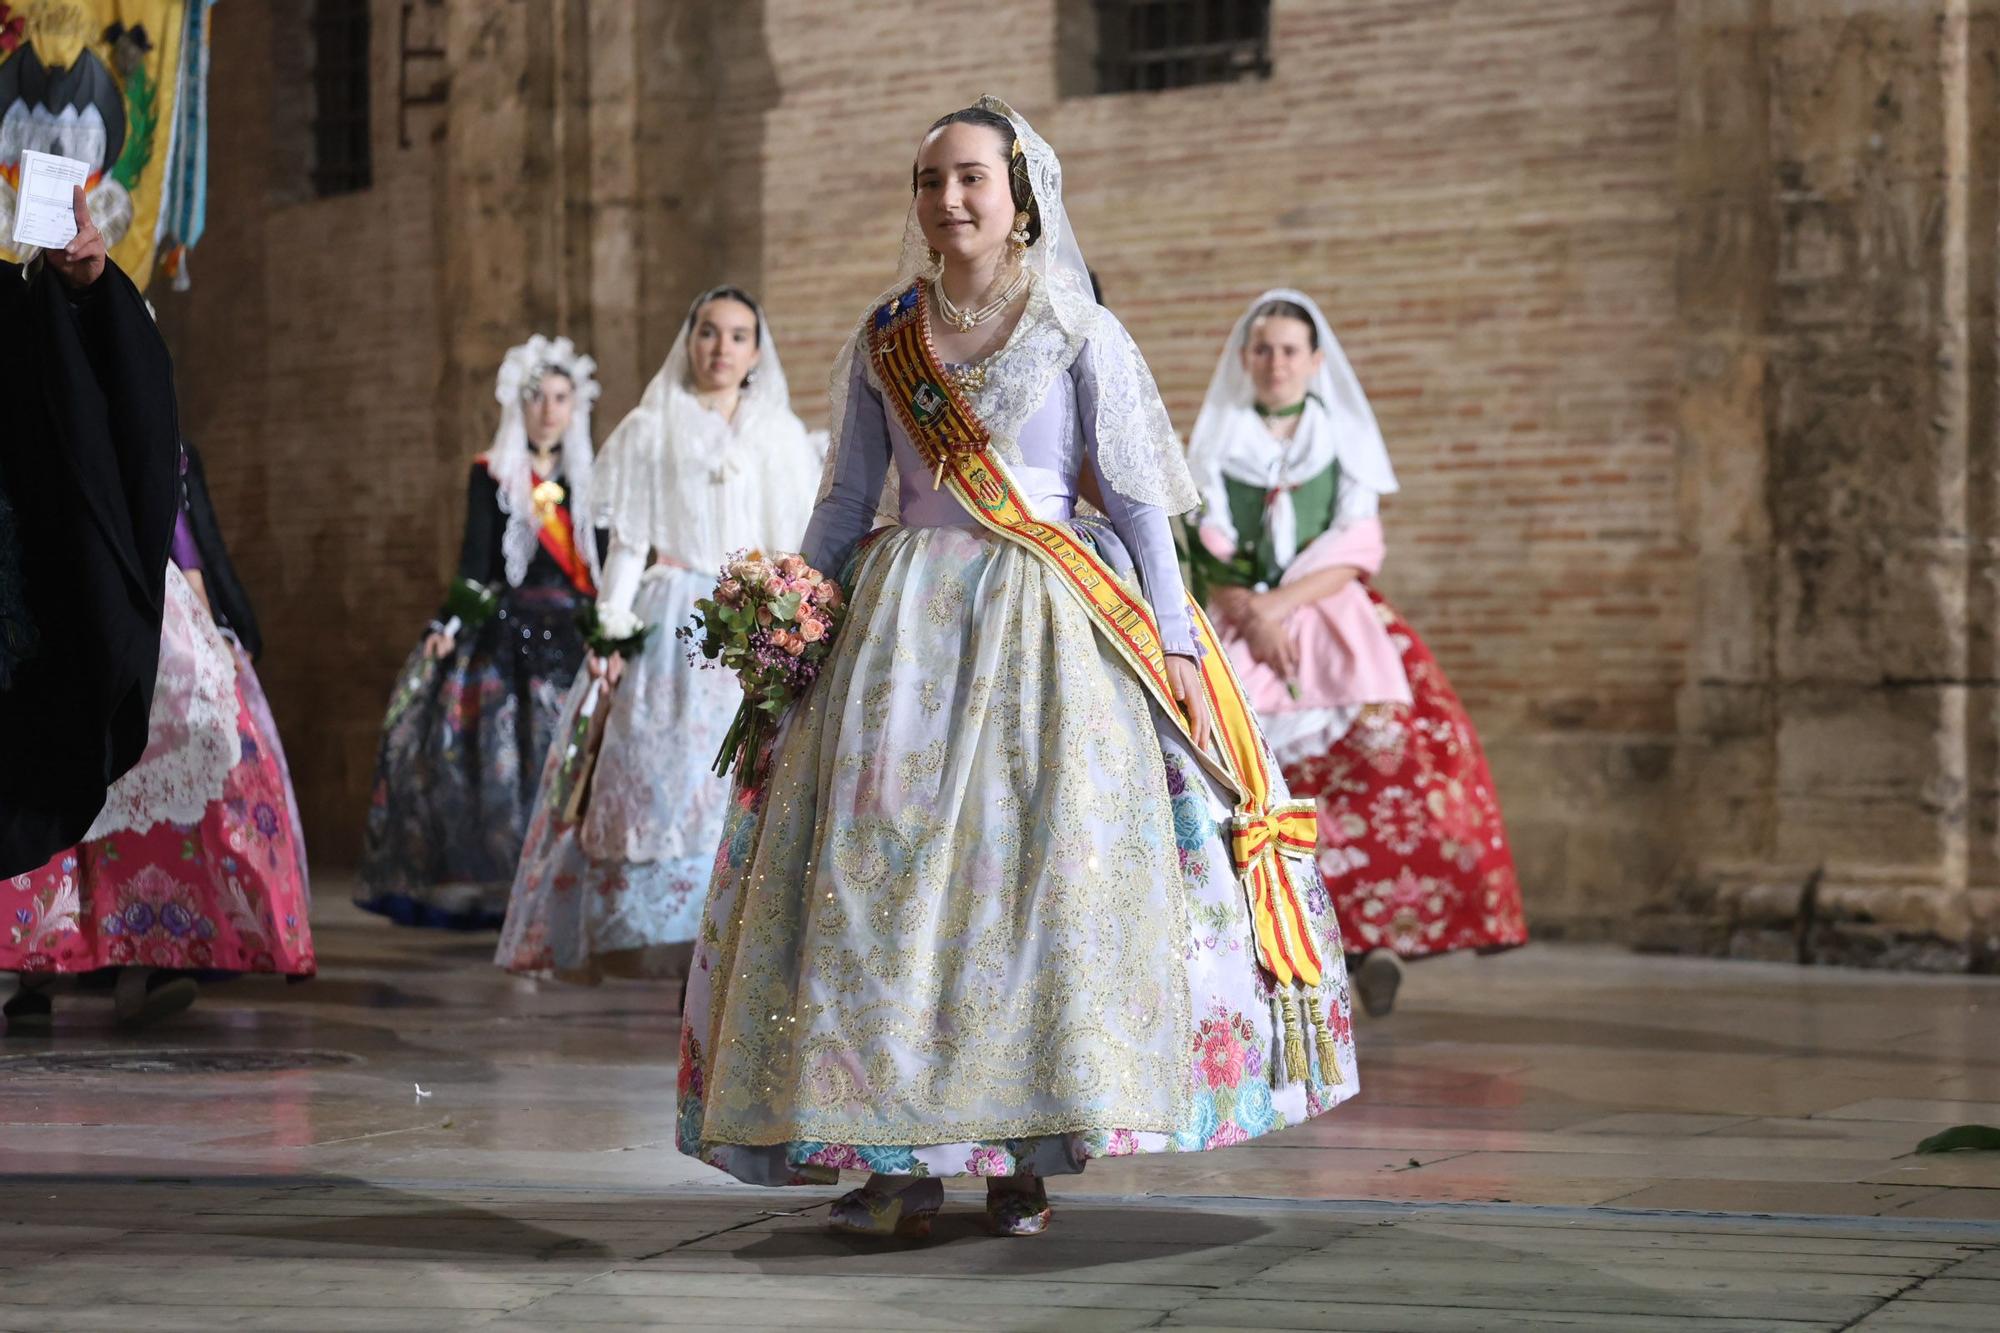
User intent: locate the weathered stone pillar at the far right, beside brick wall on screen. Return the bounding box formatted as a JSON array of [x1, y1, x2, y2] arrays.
[[1678, 0, 2000, 969]]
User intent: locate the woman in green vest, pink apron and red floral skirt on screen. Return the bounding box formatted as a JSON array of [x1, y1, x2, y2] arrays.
[[1188, 288, 1528, 1015]]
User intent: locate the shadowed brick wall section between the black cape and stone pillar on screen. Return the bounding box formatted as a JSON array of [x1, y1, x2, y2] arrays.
[[152, 2, 454, 865]]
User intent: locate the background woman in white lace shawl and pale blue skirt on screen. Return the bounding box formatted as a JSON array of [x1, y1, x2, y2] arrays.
[[494, 286, 826, 981]]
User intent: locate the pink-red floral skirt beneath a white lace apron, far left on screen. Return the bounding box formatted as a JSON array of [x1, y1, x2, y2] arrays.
[[0, 628, 314, 977]]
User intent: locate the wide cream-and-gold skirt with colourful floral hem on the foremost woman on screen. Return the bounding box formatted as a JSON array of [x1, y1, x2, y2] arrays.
[[678, 526, 1358, 1185]]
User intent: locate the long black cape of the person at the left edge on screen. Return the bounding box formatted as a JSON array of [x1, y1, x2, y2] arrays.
[[0, 264, 180, 875]]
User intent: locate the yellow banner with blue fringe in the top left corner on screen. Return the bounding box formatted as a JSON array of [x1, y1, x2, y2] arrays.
[[0, 0, 188, 288]]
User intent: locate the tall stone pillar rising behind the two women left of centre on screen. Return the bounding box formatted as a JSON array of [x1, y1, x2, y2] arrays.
[[438, 0, 764, 520]]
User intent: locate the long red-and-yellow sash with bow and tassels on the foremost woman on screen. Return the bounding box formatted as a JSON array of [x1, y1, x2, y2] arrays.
[[868, 282, 1340, 1083]]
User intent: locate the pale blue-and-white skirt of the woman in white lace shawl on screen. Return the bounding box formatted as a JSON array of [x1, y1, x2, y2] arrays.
[[494, 566, 742, 981]]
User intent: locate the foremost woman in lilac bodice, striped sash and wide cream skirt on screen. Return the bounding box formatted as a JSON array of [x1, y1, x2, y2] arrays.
[[678, 98, 1356, 1235]]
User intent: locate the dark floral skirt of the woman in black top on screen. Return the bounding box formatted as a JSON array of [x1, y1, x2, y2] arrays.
[[354, 586, 584, 931]]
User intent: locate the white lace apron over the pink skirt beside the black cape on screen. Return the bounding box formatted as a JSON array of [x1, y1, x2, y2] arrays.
[[84, 564, 242, 841]]
